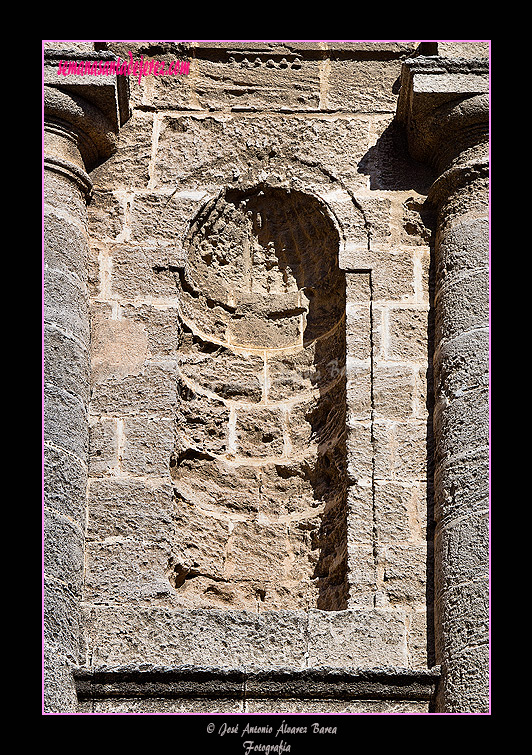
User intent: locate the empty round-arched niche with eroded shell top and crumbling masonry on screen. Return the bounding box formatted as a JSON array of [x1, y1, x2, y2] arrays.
[[168, 185, 347, 610]]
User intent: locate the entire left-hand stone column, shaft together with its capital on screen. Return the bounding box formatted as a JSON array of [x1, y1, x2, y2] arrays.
[[43, 50, 127, 712]]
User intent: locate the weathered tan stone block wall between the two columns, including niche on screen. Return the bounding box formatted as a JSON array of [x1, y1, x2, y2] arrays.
[[42, 42, 487, 712]]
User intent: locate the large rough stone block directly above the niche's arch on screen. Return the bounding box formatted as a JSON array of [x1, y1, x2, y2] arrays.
[[153, 112, 369, 193]]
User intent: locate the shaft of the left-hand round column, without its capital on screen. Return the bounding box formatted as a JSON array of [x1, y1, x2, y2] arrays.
[[44, 124, 90, 712]]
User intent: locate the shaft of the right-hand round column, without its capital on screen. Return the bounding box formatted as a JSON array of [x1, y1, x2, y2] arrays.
[[433, 165, 489, 712]]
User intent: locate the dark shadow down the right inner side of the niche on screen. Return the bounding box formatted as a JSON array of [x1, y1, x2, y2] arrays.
[[244, 189, 348, 610]]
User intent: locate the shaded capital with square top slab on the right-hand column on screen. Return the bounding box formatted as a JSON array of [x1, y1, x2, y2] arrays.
[[397, 56, 489, 174]]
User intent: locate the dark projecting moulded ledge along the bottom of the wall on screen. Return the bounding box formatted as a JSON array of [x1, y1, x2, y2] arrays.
[[74, 664, 440, 701]]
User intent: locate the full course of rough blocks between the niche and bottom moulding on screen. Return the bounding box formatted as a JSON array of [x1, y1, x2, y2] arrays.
[[83, 604, 416, 671]]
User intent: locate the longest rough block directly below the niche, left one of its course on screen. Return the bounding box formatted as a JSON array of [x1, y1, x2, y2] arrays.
[[85, 606, 307, 669]]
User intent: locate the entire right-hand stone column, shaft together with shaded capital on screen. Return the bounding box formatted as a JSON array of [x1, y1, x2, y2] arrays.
[[398, 57, 489, 713]]
